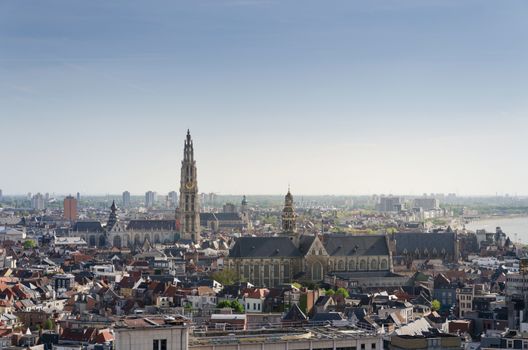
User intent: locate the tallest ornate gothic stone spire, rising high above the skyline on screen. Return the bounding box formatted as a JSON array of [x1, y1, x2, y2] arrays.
[[179, 130, 200, 243]]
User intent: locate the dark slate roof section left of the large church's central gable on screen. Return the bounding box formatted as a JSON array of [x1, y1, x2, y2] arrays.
[[229, 237, 301, 258]]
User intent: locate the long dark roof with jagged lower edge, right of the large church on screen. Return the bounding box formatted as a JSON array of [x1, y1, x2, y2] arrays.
[[393, 232, 456, 255]]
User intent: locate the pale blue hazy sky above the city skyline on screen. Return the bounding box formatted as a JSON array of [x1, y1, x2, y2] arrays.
[[0, 0, 528, 195]]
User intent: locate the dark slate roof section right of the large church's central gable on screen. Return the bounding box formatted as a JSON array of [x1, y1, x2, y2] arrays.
[[323, 234, 389, 256]]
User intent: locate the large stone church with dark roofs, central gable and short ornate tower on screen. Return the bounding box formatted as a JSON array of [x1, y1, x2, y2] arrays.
[[226, 190, 392, 287]]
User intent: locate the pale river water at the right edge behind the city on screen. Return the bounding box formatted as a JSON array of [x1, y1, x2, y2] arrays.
[[466, 217, 528, 244]]
